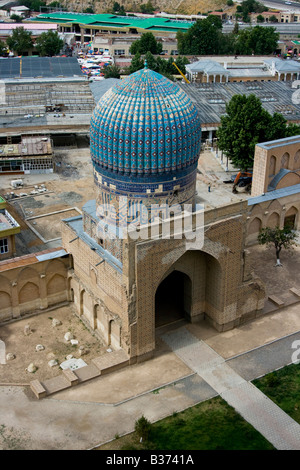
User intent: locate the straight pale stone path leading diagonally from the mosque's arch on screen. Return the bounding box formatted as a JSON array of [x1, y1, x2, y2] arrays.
[[162, 327, 300, 450]]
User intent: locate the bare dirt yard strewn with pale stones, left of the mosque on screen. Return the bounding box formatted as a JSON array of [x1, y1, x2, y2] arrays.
[[0, 306, 107, 384]]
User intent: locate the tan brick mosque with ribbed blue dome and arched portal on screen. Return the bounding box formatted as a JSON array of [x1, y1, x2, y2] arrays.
[[62, 66, 265, 363]]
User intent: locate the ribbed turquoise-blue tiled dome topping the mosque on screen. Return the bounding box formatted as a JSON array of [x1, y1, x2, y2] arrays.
[[90, 67, 201, 177]]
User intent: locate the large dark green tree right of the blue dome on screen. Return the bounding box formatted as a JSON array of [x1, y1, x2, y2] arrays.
[[217, 94, 300, 170]]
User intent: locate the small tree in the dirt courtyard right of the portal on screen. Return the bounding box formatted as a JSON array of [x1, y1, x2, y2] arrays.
[[258, 226, 297, 266]]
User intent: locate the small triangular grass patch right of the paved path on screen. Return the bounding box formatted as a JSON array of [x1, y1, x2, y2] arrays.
[[253, 364, 300, 424]]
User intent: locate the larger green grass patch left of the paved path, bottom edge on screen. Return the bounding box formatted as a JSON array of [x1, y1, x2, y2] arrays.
[[98, 397, 274, 450]]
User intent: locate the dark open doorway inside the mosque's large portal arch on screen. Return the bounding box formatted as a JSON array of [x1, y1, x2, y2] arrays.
[[155, 271, 192, 327]]
